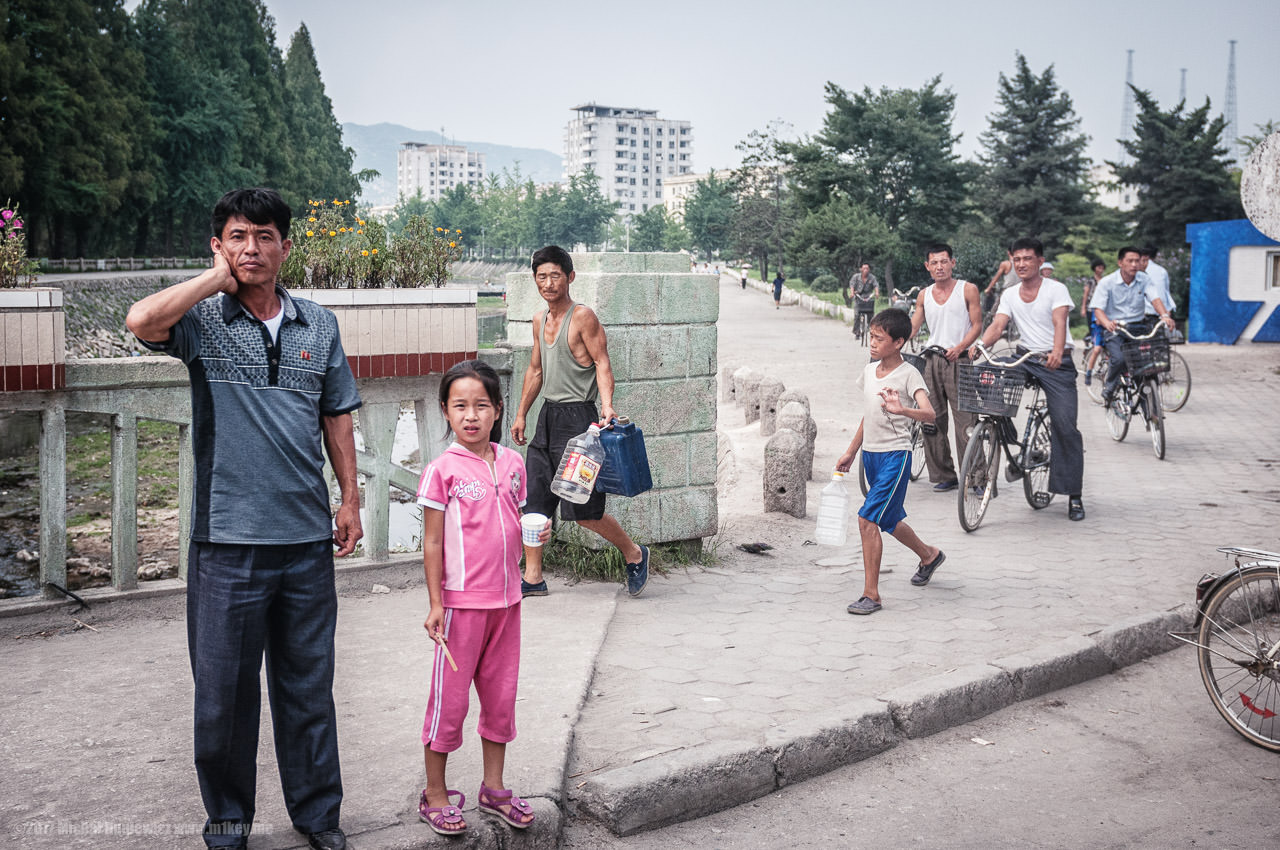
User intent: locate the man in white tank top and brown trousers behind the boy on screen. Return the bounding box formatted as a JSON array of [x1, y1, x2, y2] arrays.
[[911, 242, 982, 493]]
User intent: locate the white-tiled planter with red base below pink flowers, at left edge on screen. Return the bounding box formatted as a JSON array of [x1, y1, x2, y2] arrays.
[[0, 287, 67, 392]]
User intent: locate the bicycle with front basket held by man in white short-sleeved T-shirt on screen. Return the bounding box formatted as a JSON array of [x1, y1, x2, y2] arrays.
[[956, 342, 1053, 531]]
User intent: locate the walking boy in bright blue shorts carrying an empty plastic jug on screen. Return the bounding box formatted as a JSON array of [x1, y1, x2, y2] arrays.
[[836, 307, 946, 614]]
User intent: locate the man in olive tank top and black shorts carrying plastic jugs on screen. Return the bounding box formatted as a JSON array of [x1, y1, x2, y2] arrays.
[[511, 245, 649, 597]]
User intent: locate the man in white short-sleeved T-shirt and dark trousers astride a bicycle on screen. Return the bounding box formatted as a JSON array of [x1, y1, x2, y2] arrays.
[[982, 237, 1084, 521]]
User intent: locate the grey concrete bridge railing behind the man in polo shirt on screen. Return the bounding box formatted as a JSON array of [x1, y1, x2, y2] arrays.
[[0, 348, 511, 612]]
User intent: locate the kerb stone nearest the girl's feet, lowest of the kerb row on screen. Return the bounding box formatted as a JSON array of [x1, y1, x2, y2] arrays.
[[577, 741, 776, 836]]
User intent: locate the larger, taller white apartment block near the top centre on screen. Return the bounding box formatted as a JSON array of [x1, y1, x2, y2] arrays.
[[564, 104, 694, 216]]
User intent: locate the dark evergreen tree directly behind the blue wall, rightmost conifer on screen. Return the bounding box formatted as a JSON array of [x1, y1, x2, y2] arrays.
[[1111, 88, 1244, 251]]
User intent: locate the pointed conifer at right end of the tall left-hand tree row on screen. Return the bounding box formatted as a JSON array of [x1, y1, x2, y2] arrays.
[[284, 24, 358, 208]]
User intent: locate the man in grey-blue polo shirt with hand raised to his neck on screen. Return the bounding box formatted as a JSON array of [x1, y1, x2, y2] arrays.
[[125, 188, 362, 850]]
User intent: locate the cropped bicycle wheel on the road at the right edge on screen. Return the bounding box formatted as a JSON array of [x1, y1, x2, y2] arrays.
[[1197, 566, 1280, 753]]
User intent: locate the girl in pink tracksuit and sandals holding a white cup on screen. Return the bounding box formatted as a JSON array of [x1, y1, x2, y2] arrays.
[[417, 360, 550, 835]]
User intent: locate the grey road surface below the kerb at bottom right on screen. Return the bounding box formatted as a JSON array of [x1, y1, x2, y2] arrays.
[[563, 649, 1280, 850]]
